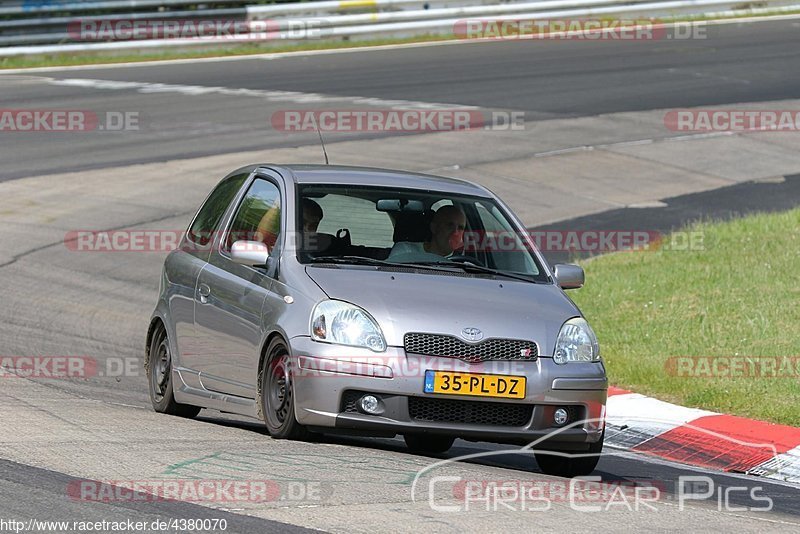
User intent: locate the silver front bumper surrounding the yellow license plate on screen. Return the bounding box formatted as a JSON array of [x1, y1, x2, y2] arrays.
[[291, 337, 608, 450]]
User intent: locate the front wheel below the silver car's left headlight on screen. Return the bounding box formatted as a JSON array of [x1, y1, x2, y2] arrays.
[[259, 339, 311, 440]]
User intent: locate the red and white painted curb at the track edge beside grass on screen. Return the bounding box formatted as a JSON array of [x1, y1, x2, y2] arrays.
[[605, 387, 800, 482]]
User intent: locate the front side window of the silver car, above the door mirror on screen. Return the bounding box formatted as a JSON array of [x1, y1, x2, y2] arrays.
[[223, 178, 281, 251]]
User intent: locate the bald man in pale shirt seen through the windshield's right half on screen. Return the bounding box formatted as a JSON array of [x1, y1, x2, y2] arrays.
[[387, 205, 467, 262]]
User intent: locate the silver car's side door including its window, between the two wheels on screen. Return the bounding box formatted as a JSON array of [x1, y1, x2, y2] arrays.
[[195, 176, 285, 398]]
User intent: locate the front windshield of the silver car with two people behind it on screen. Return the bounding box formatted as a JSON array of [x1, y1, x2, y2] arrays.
[[296, 185, 548, 282]]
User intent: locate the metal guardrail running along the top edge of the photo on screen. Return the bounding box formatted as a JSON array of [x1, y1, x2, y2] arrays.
[[0, 0, 800, 56]]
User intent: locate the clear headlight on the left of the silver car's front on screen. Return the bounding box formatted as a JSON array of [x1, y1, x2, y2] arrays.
[[311, 300, 386, 352]]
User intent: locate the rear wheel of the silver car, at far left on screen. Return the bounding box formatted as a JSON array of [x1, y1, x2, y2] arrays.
[[146, 325, 200, 419]]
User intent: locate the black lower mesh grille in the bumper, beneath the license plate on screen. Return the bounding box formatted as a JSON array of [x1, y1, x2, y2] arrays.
[[408, 397, 533, 427]]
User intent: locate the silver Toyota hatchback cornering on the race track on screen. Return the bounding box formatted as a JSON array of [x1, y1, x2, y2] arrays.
[[145, 165, 608, 476]]
